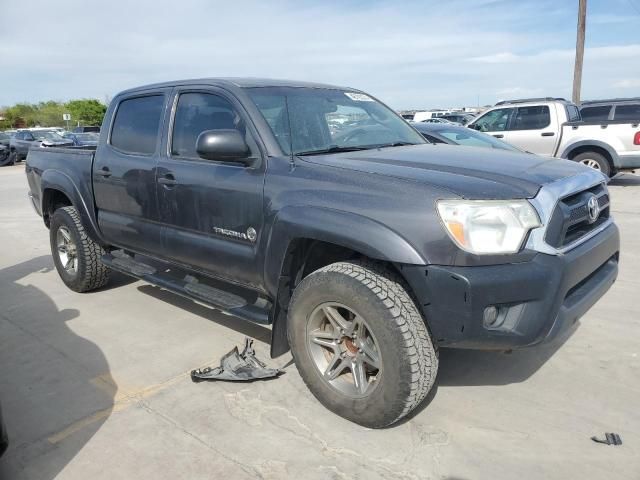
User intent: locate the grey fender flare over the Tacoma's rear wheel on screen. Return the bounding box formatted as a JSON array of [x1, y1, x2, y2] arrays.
[[40, 170, 105, 245]]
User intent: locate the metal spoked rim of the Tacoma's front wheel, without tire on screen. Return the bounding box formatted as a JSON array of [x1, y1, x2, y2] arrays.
[[307, 302, 383, 398]]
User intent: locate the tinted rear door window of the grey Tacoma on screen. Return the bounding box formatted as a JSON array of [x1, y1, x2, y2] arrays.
[[109, 94, 165, 155]]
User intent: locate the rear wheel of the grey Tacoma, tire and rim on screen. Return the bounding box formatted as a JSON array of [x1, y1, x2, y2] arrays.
[[49, 207, 110, 292]]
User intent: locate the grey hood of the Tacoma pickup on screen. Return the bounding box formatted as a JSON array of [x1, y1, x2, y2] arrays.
[[301, 144, 588, 200]]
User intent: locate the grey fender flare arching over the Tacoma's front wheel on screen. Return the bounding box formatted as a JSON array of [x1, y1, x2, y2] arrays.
[[264, 205, 427, 292]]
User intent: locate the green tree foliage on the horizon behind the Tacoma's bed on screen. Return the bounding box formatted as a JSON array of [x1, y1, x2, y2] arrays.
[[0, 99, 107, 129]]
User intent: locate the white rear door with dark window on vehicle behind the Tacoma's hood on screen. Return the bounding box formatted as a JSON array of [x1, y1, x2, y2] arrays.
[[504, 105, 559, 155]]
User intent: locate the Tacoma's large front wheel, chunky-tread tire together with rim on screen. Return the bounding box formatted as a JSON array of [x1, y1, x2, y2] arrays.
[[287, 262, 438, 428]]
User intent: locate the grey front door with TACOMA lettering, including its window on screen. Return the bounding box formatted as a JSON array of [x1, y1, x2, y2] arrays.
[[157, 87, 266, 288]]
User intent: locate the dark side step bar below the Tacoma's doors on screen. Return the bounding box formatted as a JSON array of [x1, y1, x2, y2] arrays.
[[100, 253, 269, 325]]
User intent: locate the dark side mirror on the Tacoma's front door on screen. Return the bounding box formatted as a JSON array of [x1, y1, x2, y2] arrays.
[[196, 129, 255, 166]]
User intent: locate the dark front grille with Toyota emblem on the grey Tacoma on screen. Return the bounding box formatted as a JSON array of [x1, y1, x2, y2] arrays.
[[545, 185, 609, 248]]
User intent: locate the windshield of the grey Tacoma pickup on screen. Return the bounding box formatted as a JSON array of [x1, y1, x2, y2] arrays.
[[246, 87, 425, 155]]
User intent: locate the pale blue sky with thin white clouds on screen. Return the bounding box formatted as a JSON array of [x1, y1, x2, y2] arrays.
[[0, 0, 640, 109]]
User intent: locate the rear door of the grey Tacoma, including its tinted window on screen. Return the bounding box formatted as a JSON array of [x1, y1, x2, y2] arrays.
[[93, 89, 171, 254]]
